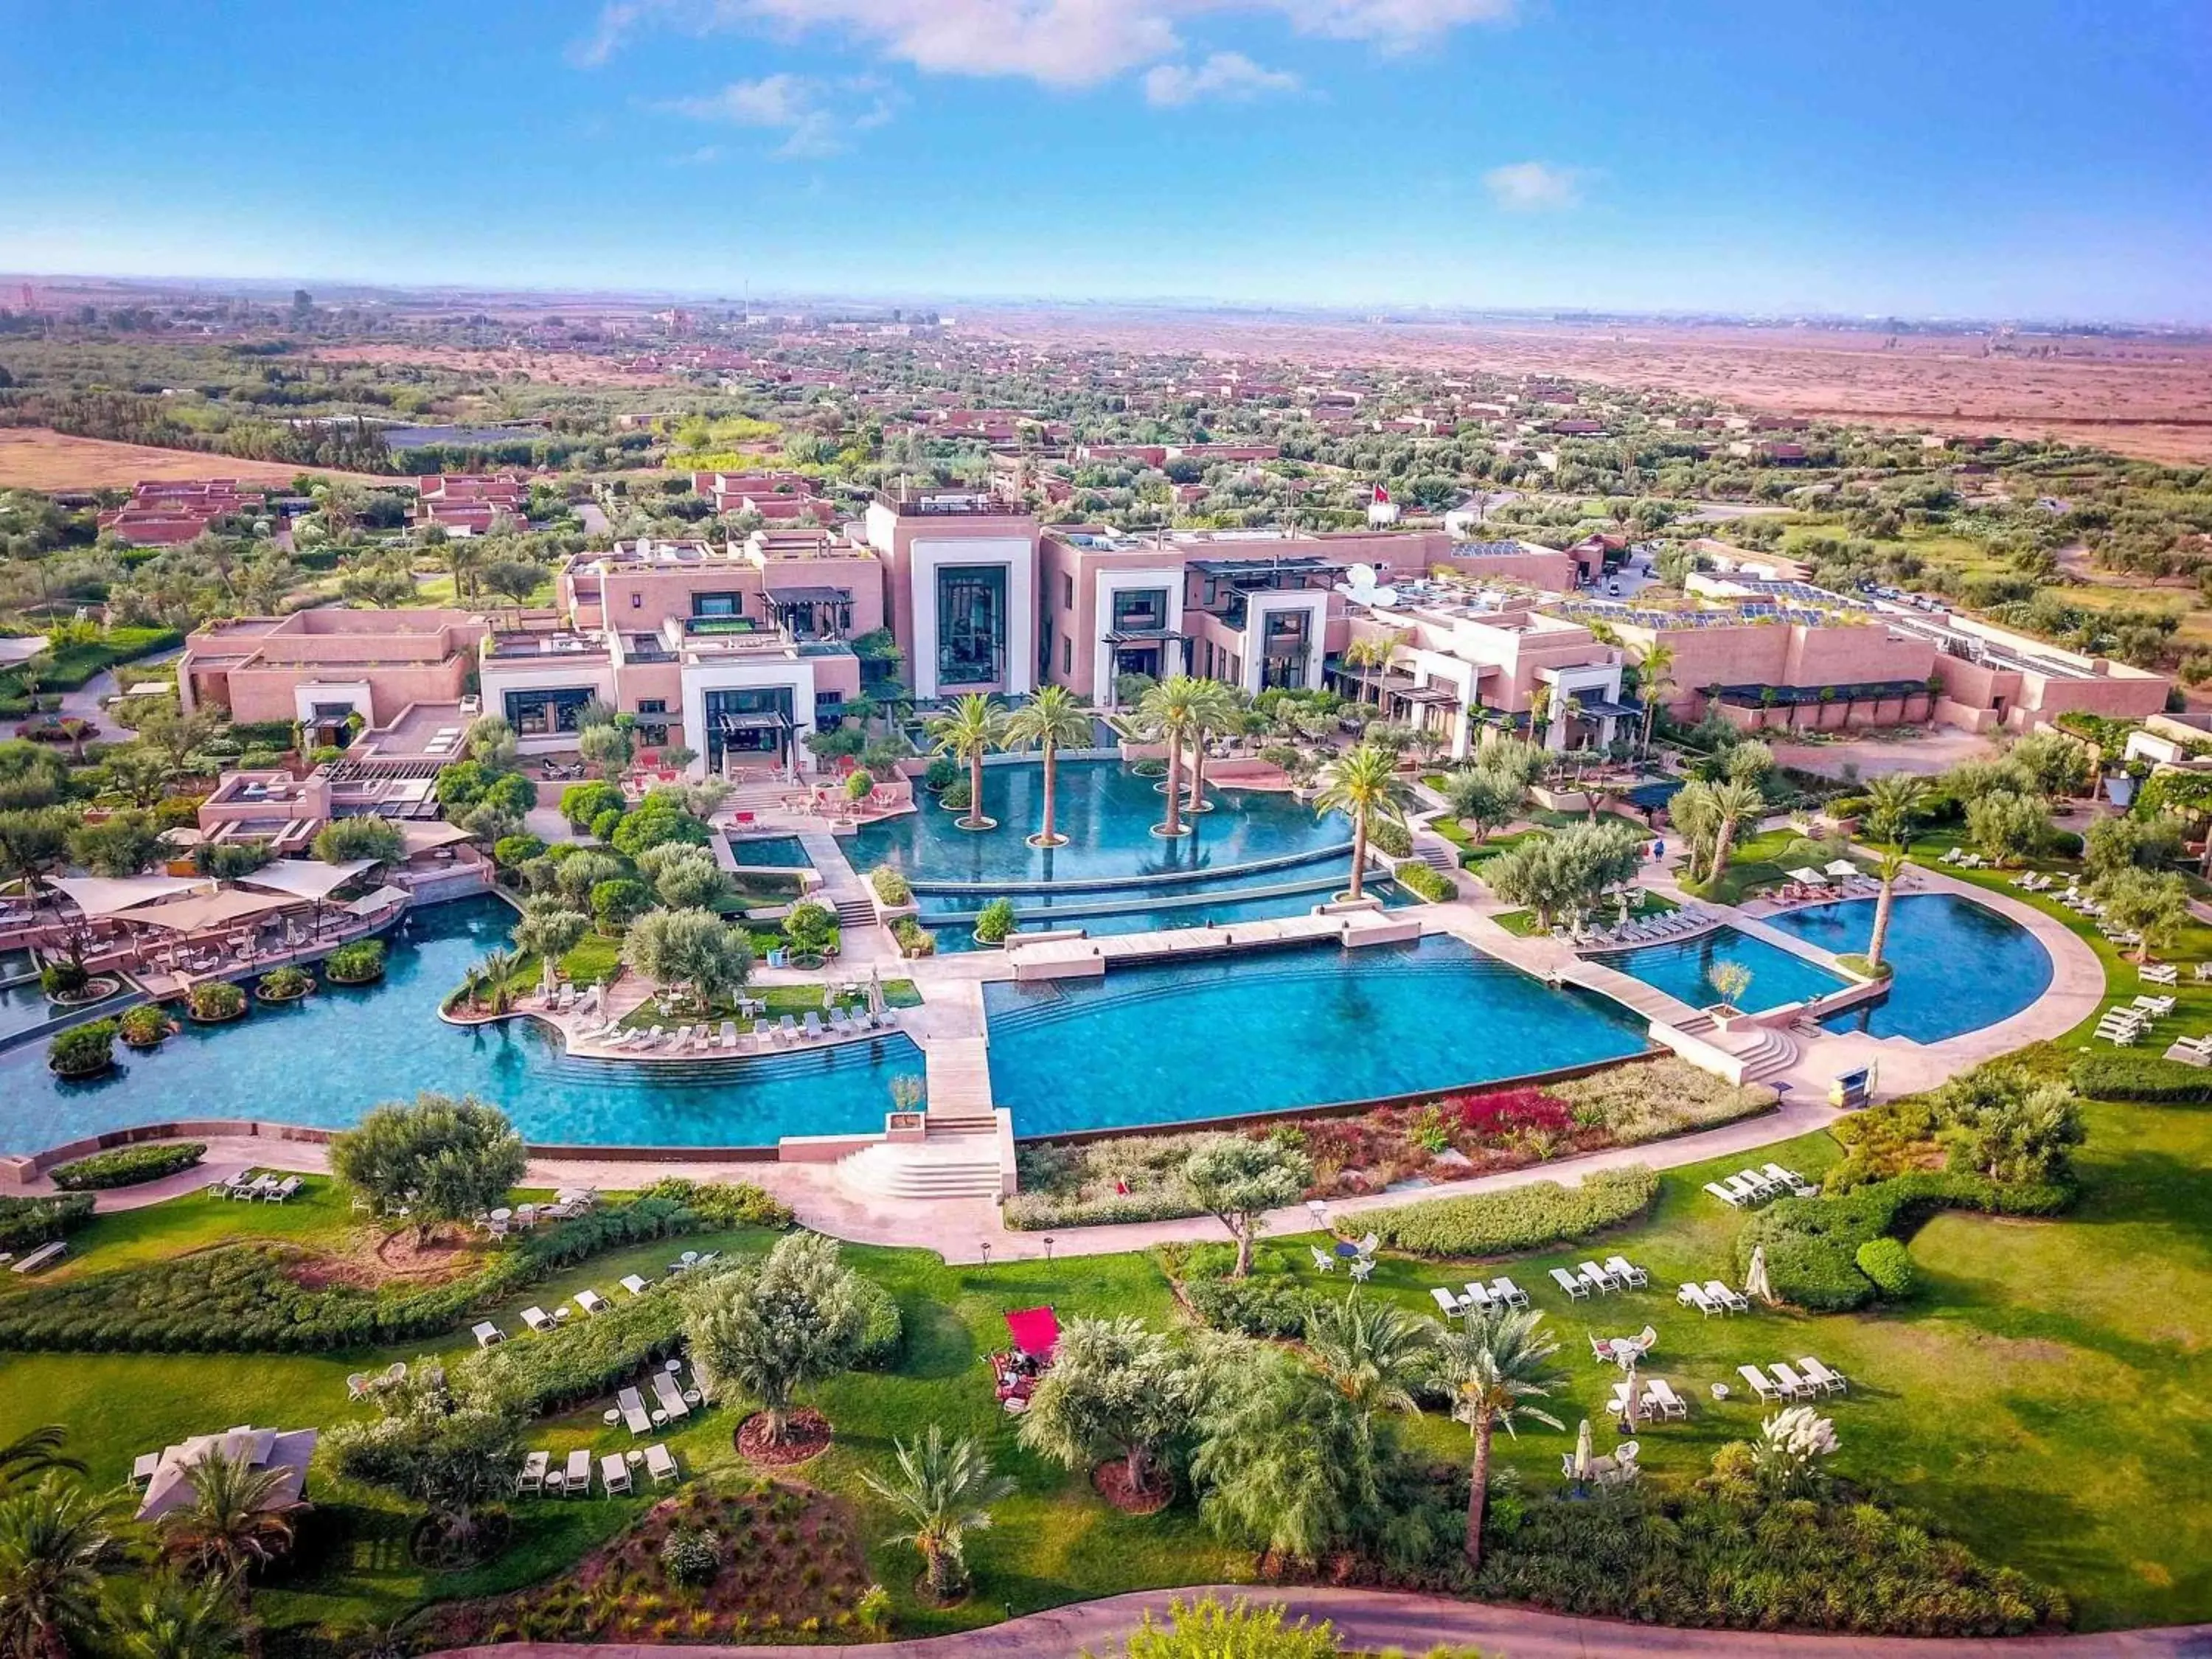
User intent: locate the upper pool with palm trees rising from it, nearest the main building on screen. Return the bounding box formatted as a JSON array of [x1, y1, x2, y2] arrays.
[[845, 761, 1352, 898]]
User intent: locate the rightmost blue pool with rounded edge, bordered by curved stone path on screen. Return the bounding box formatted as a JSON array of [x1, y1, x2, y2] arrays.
[[1770, 894, 2053, 1042]]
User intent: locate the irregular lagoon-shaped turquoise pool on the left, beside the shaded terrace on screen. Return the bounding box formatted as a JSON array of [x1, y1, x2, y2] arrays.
[[0, 898, 922, 1152]]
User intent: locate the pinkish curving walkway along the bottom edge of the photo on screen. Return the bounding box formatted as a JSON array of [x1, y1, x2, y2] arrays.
[[418, 1584, 2212, 1659]]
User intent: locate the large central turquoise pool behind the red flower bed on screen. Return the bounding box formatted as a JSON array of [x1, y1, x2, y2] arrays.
[[984, 938, 1646, 1137]]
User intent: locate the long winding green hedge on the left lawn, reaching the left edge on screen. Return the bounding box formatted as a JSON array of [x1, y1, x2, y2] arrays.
[[0, 1197, 730, 1354]]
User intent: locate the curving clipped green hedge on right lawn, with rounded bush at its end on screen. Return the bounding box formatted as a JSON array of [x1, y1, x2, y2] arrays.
[[1736, 1170, 2073, 1314]]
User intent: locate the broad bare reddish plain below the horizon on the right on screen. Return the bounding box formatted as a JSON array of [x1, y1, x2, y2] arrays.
[[962, 310, 2212, 462]]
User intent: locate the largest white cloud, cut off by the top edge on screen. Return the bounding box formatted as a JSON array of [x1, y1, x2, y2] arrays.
[[573, 0, 1517, 86]]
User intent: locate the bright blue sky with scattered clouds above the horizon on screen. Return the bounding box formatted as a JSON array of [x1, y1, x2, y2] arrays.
[[0, 0, 2212, 321]]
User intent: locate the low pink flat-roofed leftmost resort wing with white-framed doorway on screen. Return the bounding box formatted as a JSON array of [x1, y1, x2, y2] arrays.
[[177, 611, 491, 741]]
